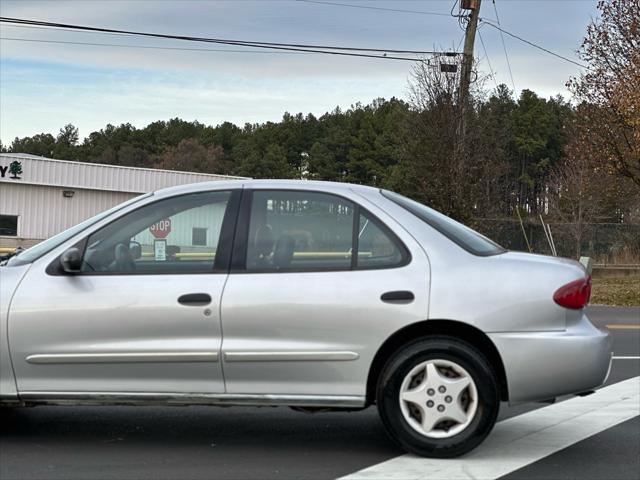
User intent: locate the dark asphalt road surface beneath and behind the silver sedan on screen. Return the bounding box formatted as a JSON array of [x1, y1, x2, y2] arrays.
[[0, 307, 640, 480]]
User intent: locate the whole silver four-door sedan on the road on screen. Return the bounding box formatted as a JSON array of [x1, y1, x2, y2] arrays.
[[0, 180, 611, 457]]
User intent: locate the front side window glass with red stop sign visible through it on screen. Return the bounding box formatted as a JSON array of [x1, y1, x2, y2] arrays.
[[82, 191, 231, 274]]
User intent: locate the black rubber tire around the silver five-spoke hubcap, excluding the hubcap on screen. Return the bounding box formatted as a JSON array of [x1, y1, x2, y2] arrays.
[[376, 336, 500, 458]]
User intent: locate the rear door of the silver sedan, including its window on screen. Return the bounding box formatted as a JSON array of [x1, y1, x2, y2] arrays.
[[222, 189, 429, 404]]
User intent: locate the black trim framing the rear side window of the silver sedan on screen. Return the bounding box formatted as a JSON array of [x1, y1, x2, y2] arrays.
[[230, 188, 412, 274]]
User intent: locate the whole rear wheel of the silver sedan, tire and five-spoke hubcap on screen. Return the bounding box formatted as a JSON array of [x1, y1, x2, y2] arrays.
[[376, 336, 500, 458]]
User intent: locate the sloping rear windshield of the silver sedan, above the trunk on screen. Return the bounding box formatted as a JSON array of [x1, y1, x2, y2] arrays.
[[380, 190, 506, 257]]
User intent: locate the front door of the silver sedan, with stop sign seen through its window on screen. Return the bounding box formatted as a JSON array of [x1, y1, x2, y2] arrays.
[[9, 190, 240, 399]]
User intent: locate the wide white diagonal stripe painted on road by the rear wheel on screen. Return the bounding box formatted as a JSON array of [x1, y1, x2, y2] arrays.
[[341, 377, 640, 480]]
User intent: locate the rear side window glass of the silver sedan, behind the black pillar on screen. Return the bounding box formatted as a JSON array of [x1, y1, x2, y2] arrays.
[[246, 190, 409, 272]]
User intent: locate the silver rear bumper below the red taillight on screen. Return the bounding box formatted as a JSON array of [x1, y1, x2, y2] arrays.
[[489, 314, 612, 403]]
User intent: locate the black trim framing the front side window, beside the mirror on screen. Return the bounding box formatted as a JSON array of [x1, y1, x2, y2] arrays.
[[45, 188, 242, 276]]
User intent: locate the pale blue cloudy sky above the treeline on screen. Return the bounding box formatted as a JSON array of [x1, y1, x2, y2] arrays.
[[0, 0, 597, 145]]
